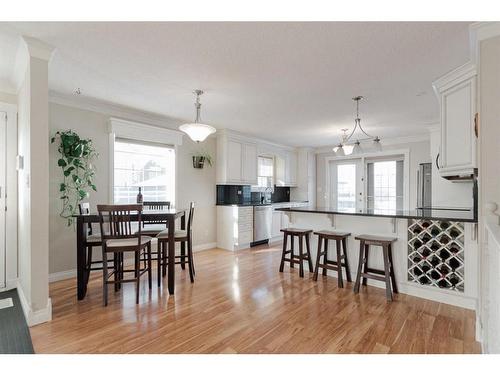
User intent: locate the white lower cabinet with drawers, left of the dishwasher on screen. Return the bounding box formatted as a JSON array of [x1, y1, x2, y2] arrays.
[[217, 206, 253, 251]]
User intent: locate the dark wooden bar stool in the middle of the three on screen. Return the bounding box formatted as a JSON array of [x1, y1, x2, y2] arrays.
[[313, 230, 352, 288]]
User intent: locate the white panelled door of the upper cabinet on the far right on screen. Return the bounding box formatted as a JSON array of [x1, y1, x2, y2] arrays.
[[440, 78, 476, 174]]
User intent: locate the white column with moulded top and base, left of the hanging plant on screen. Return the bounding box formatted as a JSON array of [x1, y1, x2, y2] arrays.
[[16, 37, 53, 325]]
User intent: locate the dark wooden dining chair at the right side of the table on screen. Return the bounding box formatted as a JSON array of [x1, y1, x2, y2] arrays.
[[156, 202, 195, 286]]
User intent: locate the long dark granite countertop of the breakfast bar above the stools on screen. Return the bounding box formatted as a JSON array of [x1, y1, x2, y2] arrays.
[[276, 206, 477, 223]]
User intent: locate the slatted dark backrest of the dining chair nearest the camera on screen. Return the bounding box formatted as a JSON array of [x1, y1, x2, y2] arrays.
[[97, 204, 142, 245]]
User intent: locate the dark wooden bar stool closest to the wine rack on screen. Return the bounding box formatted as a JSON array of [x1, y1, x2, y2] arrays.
[[354, 234, 398, 301]]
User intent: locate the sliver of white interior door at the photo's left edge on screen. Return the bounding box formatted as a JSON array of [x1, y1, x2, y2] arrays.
[[0, 112, 7, 288]]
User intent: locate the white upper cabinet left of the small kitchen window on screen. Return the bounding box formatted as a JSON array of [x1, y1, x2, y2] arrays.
[[216, 132, 257, 185]]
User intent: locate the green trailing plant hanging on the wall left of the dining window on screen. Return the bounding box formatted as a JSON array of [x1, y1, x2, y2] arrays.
[[50, 130, 98, 226]]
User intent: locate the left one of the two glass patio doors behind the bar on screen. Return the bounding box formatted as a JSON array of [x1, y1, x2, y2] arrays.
[[329, 159, 364, 212]]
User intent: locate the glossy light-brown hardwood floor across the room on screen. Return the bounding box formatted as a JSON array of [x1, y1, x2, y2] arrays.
[[31, 246, 480, 353]]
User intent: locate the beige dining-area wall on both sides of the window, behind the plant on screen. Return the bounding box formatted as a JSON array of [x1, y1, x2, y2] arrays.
[[49, 103, 216, 273]]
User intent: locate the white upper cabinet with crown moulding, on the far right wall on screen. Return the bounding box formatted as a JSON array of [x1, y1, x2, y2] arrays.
[[433, 63, 477, 178]]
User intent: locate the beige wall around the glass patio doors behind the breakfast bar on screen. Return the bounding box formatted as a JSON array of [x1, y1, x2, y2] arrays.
[[316, 141, 431, 209]]
